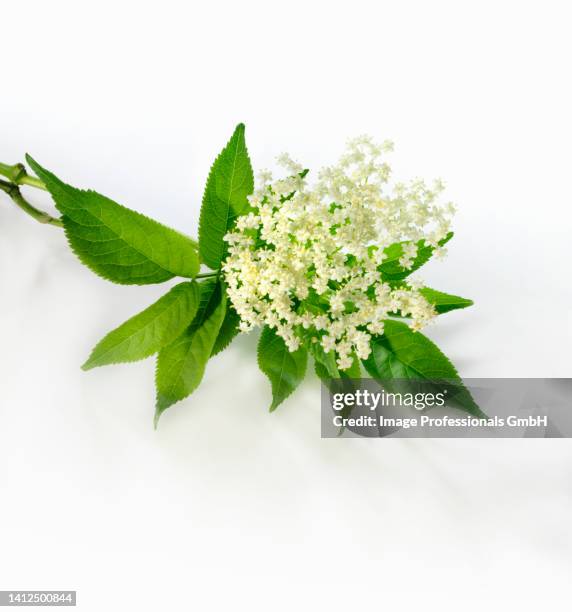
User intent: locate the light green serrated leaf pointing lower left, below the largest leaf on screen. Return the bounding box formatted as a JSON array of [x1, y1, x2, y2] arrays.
[[82, 282, 199, 370]]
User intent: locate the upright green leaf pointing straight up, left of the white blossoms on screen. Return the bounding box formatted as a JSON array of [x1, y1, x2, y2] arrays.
[[199, 123, 254, 270]]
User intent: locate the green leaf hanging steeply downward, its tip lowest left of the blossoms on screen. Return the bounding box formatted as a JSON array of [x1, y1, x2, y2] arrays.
[[155, 280, 226, 426]]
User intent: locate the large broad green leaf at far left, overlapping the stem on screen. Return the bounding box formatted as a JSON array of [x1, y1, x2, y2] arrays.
[[26, 156, 199, 285]]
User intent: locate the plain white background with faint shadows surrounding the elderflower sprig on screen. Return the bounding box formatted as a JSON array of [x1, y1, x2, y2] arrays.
[[0, 0, 572, 611]]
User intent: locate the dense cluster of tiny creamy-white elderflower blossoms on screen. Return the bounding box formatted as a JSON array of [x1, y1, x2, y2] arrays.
[[223, 137, 454, 370]]
